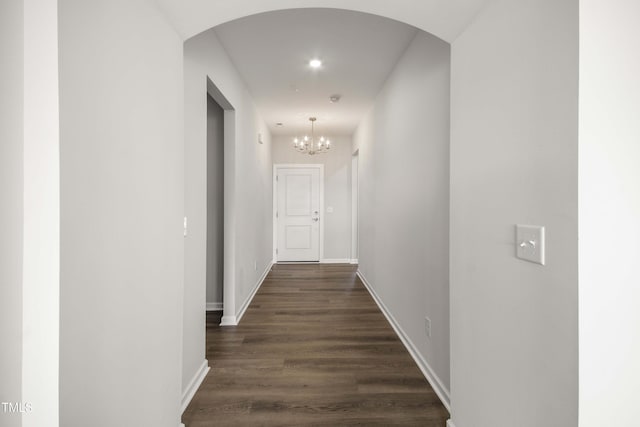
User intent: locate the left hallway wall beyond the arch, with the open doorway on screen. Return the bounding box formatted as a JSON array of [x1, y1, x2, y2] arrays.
[[183, 30, 272, 398]]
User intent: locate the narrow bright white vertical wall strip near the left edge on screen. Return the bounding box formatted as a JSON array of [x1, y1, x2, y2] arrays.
[[22, 0, 60, 427]]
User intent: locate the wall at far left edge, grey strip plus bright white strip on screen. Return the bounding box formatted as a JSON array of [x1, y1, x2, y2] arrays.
[[0, 0, 60, 426]]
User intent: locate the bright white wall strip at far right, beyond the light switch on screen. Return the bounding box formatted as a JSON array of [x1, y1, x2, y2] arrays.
[[579, 0, 640, 427]]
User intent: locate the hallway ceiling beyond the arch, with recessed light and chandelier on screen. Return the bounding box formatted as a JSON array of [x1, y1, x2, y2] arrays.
[[215, 9, 418, 135]]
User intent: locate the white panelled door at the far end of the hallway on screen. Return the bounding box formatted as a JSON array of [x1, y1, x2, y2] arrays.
[[276, 166, 322, 261]]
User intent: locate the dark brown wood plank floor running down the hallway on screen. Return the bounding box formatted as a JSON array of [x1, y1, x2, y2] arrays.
[[182, 264, 449, 427]]
